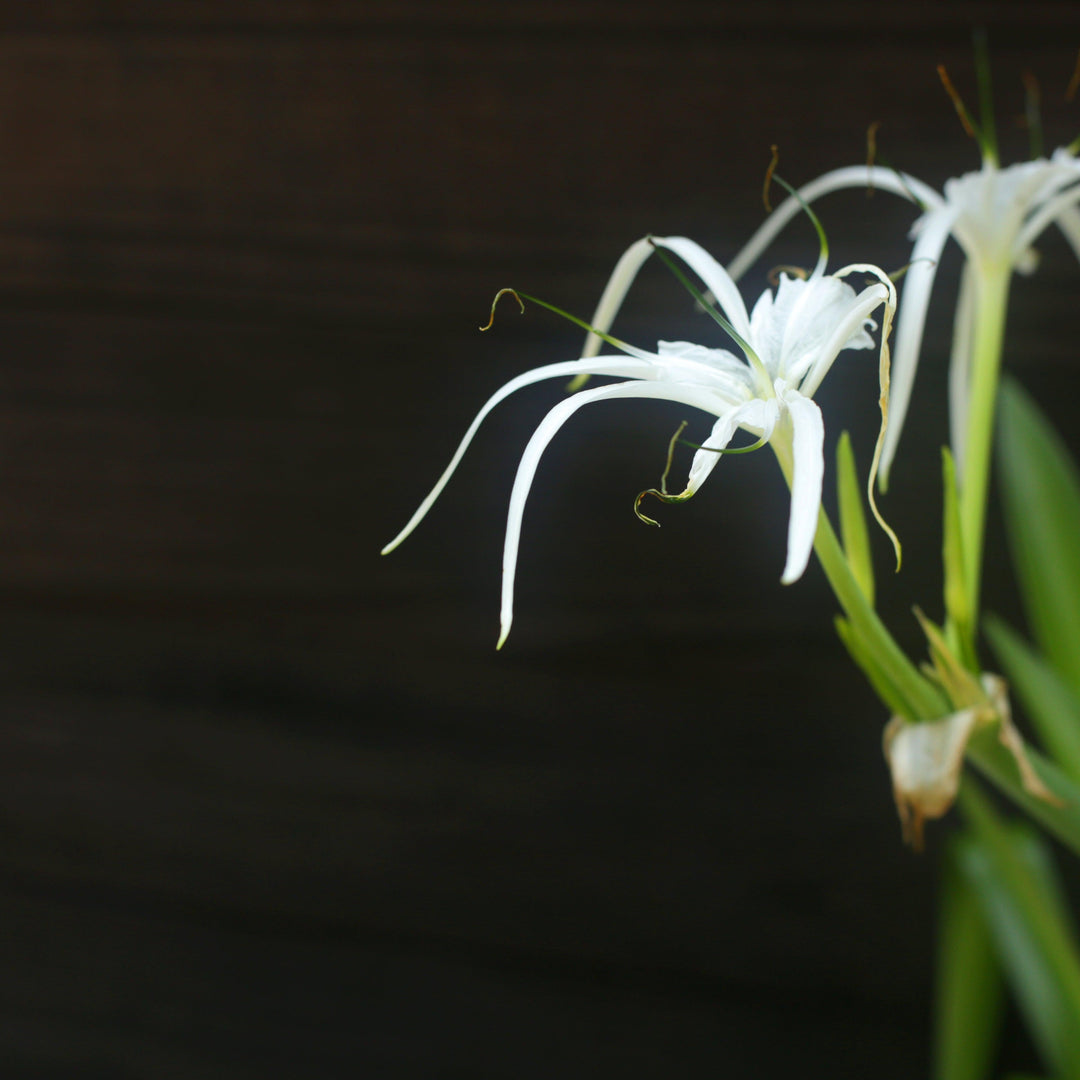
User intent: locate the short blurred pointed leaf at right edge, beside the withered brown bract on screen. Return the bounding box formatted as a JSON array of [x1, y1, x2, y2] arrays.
[[984, 616, 1080, 781]]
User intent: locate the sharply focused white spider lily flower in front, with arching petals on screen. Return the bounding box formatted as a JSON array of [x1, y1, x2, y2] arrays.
[[382, 238, 895, 647]]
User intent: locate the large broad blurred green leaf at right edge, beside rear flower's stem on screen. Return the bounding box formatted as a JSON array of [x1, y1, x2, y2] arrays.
[[998, 382, 1080, 693]]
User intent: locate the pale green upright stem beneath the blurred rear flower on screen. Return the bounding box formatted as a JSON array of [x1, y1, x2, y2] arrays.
[[960, 262, 1012, 626]]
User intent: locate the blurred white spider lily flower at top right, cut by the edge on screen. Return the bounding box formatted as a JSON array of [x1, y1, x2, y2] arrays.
[[728, 148, 1080, 487]]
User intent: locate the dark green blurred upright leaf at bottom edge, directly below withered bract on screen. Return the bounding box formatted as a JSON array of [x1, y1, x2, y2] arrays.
[[933, 836, 1004, 1080]]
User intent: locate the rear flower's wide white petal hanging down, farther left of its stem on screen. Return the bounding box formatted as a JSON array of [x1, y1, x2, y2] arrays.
[[879, 207, 956, 490]]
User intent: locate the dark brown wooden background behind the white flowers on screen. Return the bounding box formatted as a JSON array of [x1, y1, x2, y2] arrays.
[[0, 0, 1080, 1080]]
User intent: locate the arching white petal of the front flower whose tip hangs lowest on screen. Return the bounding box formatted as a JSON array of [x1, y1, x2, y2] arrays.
[[496, 381, 743, 648]]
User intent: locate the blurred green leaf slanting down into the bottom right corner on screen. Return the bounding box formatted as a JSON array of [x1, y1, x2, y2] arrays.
[[959, 779, 1080, 1077]]
